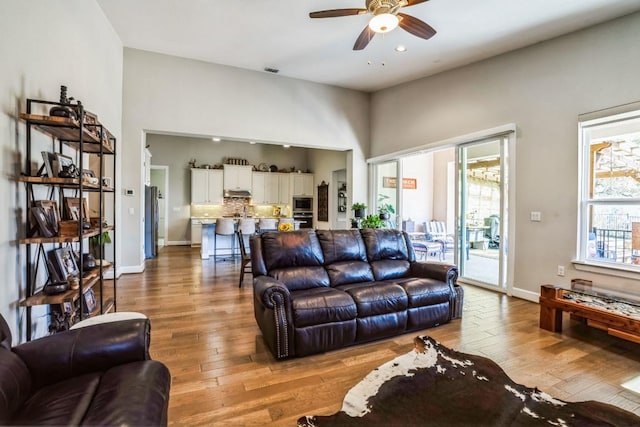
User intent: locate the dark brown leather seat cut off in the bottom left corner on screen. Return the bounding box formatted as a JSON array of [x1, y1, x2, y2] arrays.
[[0, 316, 171, 426]]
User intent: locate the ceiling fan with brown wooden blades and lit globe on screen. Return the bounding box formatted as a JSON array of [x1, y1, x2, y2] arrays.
[[309, 0, 436, 50]]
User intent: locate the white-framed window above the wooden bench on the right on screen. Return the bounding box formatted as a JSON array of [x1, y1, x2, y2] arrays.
[[578, 104, 640, 272]]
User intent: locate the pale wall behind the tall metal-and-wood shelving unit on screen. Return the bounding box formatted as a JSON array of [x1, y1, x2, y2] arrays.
[[0, 0, 122, 341]]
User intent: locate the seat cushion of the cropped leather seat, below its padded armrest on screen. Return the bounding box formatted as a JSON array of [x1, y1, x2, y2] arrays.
[[11, 373, 100, 425]]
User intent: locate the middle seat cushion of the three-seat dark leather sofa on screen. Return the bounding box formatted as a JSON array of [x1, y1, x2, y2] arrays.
[[338, 282, 408, 318]]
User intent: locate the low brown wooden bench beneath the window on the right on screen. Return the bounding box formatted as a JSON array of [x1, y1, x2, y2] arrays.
[[540, 285, 640, 344]]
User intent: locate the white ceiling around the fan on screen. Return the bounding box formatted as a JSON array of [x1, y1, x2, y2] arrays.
[[97, 0, 640, 92]]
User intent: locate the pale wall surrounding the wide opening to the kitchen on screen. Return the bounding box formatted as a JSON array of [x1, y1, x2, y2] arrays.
[[122, 49, 369, 271]]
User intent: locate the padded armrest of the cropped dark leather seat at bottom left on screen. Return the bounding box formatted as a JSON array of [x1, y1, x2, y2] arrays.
[[13, 319, 151, 388]]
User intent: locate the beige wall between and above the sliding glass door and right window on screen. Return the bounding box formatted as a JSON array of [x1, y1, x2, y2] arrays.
[[371, 13, 640, 299]]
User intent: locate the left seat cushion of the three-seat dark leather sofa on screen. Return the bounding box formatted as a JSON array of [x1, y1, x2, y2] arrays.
[[291, 288, 358, 327]]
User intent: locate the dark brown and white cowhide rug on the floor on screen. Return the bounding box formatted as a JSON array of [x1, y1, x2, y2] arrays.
[[298, 337, 640, 427]]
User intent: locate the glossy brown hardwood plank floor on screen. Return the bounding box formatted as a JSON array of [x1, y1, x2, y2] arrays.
[[118, 246, 640, 426]]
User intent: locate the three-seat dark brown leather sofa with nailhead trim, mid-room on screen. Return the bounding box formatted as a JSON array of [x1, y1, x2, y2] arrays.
[[250, 228, 463, 359]]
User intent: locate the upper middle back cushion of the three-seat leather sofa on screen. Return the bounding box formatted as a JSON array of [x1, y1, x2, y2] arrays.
[[316, 229, 367, 264]]
